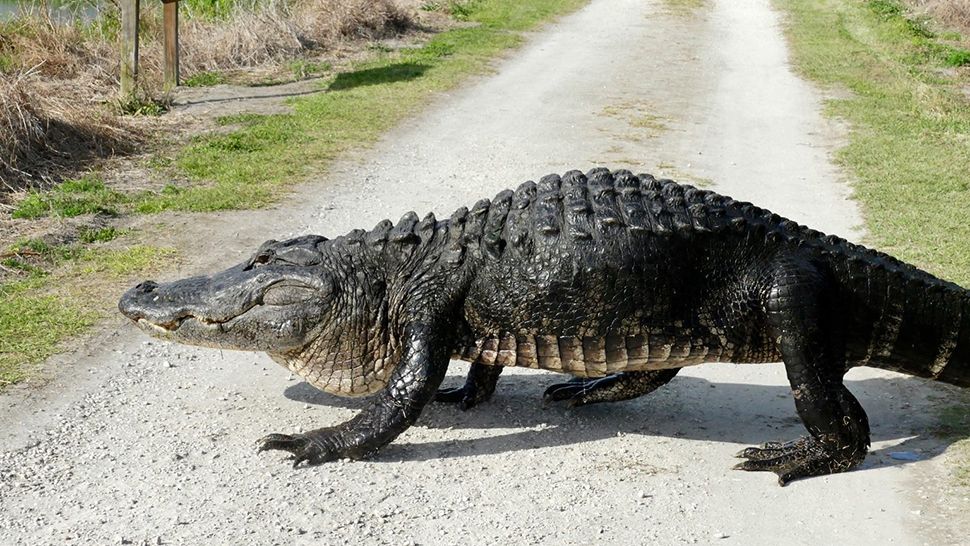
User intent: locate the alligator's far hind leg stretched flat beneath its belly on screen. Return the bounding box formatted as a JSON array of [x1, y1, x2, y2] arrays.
[[542, 368, 680, 408]]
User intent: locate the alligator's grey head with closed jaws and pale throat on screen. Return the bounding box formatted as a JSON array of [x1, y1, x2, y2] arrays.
[[118, 236, 393, 395]]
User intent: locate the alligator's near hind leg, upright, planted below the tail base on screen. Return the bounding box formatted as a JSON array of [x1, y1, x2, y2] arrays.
[[735, 263, 869, 485]]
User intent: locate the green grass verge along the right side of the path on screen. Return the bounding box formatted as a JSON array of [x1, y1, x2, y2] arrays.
[[776, 0, 970, 286]]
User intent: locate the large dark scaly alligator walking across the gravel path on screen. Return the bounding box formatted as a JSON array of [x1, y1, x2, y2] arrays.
[[119, 168, 970, 485]]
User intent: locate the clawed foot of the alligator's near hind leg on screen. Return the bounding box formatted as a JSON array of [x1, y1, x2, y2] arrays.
[[734, 437, 865, 486]]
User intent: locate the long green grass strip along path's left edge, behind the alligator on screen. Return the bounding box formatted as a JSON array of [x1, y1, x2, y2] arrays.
[[134, 0, 585, 213]]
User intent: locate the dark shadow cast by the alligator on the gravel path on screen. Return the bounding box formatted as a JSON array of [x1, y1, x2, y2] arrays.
[[284, 374, 954, 468]]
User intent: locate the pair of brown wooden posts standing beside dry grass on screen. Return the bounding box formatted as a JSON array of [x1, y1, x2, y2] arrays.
[[120, 0, 179, 98]]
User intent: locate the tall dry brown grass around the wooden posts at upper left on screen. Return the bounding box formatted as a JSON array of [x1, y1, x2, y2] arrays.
[[0, 0, 412, 194]]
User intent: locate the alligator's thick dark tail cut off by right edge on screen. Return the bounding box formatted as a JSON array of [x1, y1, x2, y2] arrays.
[[833, 249, 970, 387]]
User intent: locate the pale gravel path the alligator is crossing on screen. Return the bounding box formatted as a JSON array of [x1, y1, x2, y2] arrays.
[[0, 0, 967, 544]]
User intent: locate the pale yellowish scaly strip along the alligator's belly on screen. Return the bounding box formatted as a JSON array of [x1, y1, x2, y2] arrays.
[[455, 333, 734, 377]]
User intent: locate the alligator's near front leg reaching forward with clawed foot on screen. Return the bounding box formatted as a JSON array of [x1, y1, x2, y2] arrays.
[[258, 324, 449, 467]]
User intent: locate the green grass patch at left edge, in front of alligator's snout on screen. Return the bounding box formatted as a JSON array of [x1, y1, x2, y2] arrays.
[[0, 244, 175, 388]]
